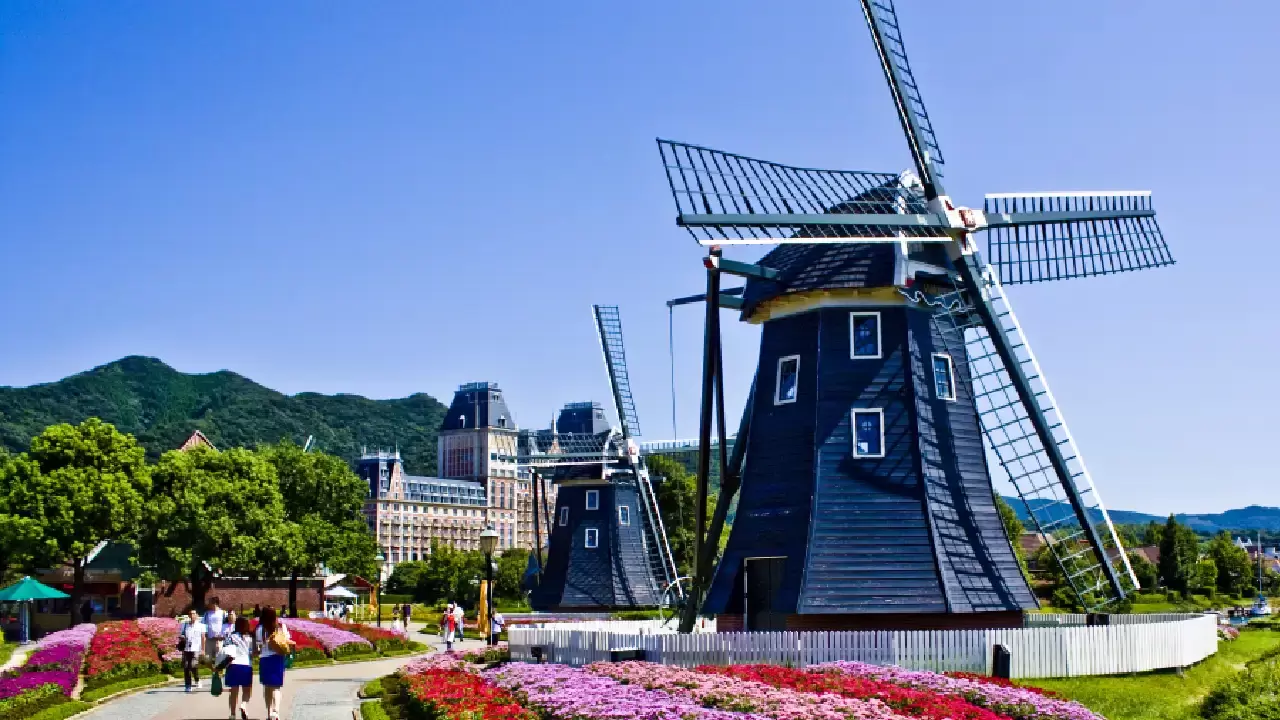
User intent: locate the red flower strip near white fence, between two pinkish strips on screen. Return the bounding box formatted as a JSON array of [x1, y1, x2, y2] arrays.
[[698, 665, 1002, 720]]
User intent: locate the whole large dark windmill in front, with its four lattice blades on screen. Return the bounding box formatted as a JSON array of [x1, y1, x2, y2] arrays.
[[659, 0, 1172, 629]]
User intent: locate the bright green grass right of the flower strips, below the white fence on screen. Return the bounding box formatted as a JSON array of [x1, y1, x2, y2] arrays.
[[1020, 630, 1280, 720]]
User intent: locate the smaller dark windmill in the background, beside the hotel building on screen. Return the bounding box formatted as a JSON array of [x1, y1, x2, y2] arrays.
[[518, 305, 675, 611]]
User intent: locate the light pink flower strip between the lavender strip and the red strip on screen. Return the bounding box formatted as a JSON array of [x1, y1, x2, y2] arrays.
[[588, 662, 902, 720]]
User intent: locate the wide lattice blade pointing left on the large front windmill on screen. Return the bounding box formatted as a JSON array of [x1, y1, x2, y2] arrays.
[[658, 140, 950, 245]]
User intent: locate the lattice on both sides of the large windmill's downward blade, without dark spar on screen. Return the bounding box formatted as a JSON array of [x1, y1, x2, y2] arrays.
[[929, 265, 1138, 611]]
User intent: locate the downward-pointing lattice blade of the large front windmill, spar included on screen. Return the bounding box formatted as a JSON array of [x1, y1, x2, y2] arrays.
[[937, 266, 1138, 602]]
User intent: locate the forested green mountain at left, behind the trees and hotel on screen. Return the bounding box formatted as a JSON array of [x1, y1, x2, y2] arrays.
[[0, 356, 448, 475]]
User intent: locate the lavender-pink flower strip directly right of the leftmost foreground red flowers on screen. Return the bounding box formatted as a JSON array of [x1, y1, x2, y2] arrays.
[[483, 662, 762, 720]]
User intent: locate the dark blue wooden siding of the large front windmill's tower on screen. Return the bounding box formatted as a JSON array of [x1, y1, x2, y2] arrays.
[[704, 305, 1037, 628]]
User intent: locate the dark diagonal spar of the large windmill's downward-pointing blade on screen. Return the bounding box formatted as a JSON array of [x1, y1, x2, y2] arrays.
[[956, 255, 1126, 600]]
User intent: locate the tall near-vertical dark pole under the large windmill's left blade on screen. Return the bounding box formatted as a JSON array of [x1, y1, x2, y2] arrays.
[[680, 247, 721, 633]]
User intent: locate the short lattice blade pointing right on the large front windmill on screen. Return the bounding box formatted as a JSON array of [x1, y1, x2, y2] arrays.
[[983, 192, 1174, 284]]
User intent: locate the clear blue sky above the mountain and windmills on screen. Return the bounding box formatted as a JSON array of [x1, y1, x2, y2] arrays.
[[0, 0, 1280, 512]]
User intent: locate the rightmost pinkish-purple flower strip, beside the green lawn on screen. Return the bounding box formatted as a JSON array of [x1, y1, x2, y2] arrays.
[[815, 661, 1103, 720]]
